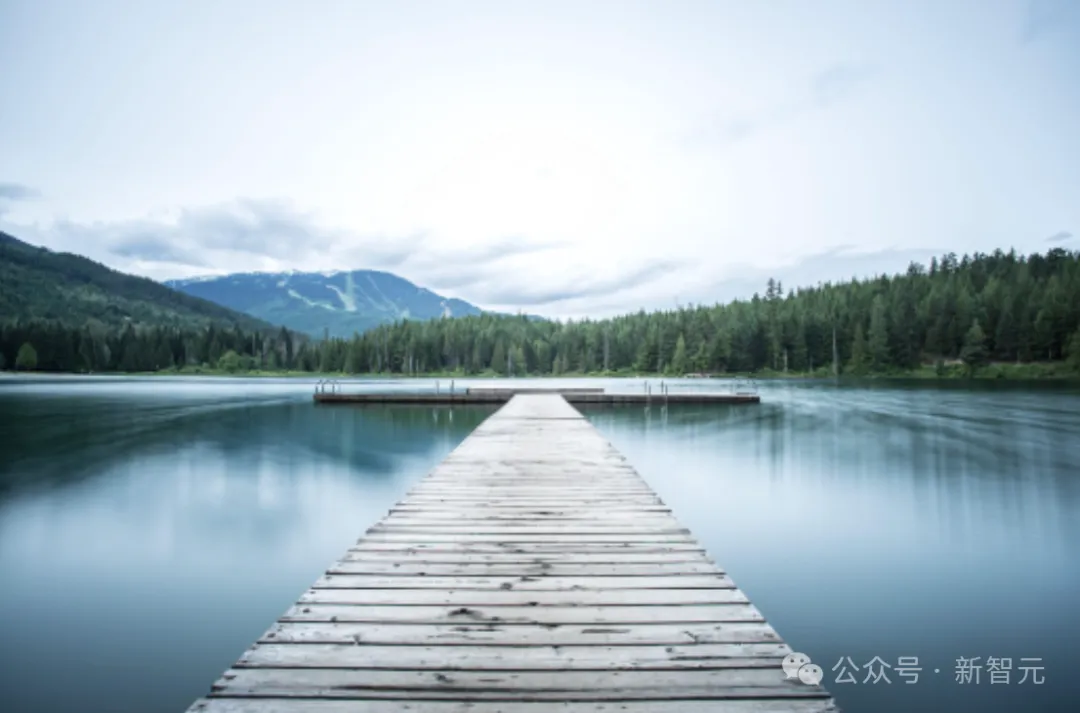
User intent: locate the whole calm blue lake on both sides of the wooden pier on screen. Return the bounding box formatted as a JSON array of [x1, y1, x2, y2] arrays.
[[0, 377, 1080, 713]]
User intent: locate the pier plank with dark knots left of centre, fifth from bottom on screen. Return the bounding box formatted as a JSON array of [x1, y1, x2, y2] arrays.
[[281, 604, 765, 624]]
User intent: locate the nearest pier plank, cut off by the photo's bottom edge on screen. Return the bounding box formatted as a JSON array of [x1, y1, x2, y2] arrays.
[[187, 697, 839, 713]]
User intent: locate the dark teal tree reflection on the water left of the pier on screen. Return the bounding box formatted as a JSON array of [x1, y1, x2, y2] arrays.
[[0, 393, 492, 490]]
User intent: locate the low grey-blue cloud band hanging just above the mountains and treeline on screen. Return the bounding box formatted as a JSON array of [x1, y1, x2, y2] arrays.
[[0, 193, 959, 318]]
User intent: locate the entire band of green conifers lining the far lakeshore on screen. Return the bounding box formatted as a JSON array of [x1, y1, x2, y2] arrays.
[[6, 248, 1080, 375]]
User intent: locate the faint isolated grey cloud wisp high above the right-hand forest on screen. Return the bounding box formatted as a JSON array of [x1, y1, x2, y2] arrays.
[[690, 62, 878, 144]]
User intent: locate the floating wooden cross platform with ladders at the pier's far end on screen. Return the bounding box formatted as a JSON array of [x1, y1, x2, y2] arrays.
[[315, 387, 761, 406]]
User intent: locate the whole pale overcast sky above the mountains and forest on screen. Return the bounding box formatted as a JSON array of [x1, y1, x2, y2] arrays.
[[0, 0, 1080, 317]]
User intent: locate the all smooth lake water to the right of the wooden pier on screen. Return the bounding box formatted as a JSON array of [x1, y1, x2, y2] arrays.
[[589, 385, 1080, 713]]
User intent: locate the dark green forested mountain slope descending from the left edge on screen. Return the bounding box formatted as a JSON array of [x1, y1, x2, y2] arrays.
[[0, 232, 272, 329]]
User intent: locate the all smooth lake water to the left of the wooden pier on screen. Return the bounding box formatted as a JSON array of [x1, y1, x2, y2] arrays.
[[0, 385, 490, 713]]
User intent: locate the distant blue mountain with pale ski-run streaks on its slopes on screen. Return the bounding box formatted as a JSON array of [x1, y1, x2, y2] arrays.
[[165, 270, 481, 337]]
